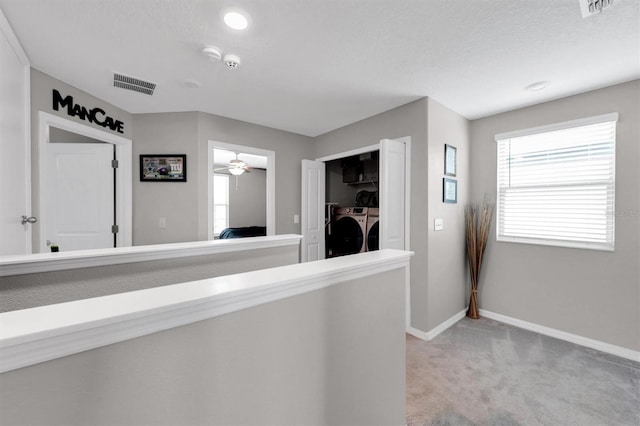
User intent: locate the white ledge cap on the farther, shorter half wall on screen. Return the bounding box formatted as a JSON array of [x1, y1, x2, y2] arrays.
[[0, 234, 302, 277]]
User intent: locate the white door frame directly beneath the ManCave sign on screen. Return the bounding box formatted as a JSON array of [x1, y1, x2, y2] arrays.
[[38, 111, 133, 253]]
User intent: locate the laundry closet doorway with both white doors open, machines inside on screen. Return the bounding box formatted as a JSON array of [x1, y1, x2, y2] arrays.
[[301, 137, 411, 262]]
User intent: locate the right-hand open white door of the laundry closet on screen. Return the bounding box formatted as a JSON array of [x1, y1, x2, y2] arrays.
[[379, 139, 406, 250]]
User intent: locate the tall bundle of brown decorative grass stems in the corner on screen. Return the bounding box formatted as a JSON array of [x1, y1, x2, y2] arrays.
[[464, 197, 495, 319]]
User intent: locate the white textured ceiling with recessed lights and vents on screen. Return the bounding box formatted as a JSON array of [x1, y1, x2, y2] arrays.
[[0, 0, 640, 136]]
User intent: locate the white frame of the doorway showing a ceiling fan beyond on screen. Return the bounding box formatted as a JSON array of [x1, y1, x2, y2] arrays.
[[207, 140, 276, 240]]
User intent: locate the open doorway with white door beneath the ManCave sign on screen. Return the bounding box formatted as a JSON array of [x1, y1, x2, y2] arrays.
[[34, 112, 132, 252]]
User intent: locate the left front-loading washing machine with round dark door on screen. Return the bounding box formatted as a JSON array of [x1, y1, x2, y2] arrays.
[[331, 207, 369, 256]]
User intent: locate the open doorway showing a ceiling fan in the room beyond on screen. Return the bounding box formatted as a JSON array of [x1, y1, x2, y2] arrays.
[[208, 141, 275, 240]]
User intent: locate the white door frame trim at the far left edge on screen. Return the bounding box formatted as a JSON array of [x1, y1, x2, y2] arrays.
[[0, 9, 33, 254]]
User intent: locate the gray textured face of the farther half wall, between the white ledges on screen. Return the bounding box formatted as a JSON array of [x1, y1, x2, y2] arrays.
[[0, 245, 298, 312]]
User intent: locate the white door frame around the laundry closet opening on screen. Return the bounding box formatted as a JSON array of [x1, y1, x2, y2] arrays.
[[315, 136, 411, 329]]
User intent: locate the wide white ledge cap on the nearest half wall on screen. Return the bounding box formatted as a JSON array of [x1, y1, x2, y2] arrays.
[[0, 250, 413, 372]]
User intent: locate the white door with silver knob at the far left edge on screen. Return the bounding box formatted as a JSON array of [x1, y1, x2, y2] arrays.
[[0, 11, 34, 256]]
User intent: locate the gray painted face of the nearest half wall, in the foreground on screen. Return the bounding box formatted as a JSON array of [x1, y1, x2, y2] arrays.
[[0, 269, 405, 425]]
